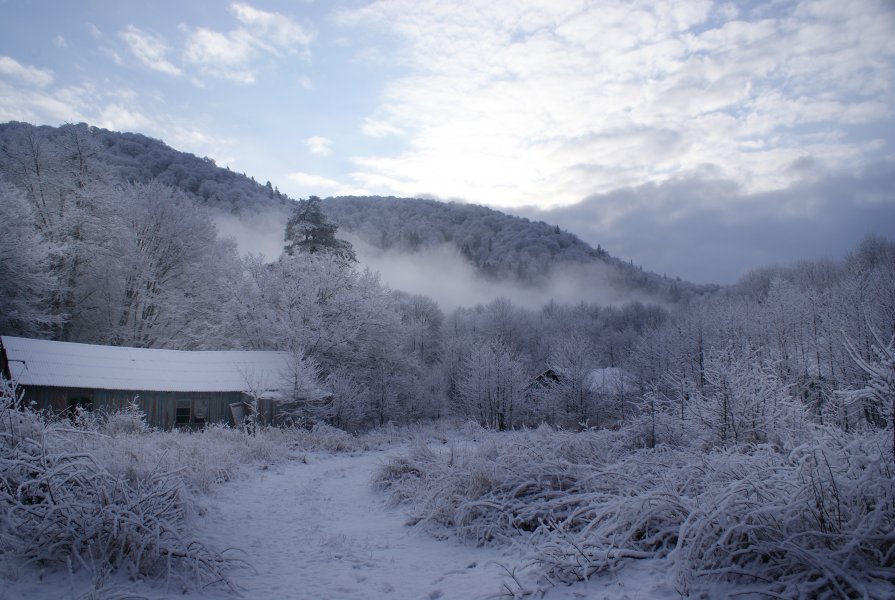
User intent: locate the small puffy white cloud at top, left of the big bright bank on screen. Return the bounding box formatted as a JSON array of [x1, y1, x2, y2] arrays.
[[183, 2, 314, 84]]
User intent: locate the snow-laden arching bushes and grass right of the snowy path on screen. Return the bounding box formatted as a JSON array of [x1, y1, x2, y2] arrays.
[[374, 428, 895, 598]]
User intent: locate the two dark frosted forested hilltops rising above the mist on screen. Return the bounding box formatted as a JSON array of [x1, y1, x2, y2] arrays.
[[0, 122, 714, 301]]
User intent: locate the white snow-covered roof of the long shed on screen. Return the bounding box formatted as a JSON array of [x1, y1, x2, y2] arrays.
[[0, 336, 291, 392]]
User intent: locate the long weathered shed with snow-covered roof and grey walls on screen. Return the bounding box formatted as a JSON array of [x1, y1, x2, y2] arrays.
[[0, 336, 292, 429]]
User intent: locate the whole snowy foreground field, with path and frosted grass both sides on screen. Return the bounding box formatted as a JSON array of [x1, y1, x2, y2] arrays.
[[0, 378, 895, 600]]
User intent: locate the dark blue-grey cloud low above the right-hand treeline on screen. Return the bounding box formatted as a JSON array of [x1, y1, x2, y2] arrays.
[[514, 157, 895, 283]]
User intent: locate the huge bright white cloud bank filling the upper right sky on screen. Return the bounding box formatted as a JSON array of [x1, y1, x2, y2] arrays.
[[339, 0, 895, 211]]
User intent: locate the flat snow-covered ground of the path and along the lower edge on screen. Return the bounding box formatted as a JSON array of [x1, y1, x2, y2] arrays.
[[0, 445, 677, 600]]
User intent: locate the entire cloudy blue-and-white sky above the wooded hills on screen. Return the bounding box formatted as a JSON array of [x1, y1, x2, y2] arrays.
[[0, 0, 895, 282]]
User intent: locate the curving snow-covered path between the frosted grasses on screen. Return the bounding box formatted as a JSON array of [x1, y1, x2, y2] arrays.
[[200, 452, 518, 600]]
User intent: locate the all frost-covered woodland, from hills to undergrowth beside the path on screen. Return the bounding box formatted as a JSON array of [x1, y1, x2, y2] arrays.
[[0, 123, 895, 598]]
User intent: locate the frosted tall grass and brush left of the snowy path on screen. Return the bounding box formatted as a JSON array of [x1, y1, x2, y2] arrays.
[[0, 380, 375, 589]]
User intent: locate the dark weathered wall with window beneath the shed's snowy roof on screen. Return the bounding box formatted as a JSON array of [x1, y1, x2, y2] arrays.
[[25, 386, 243, 429]]
